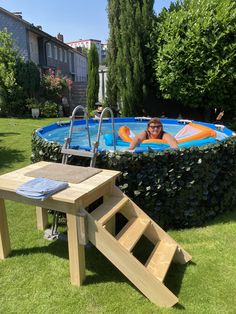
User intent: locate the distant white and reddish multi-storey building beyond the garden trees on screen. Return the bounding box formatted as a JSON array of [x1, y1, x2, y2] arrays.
[[67, 39, 107, 63]]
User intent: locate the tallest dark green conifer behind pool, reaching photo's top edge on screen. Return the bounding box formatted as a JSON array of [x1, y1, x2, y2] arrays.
[[107, 0, 154, 116]]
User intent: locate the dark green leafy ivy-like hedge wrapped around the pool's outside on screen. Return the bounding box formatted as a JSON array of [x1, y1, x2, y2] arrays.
[[32, 133, 236, 228]]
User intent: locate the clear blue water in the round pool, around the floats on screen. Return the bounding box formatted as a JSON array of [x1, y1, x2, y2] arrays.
[[36, 118, 233, 151]]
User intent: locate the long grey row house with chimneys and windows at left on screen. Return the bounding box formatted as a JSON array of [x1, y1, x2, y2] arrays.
[[0, 7, 88, 82]]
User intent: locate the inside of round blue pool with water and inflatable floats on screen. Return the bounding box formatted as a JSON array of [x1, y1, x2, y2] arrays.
[[36, 117, 235, 152]]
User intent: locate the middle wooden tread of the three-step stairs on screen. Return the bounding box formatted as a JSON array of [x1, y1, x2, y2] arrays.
[[116, 217, 150, 252]]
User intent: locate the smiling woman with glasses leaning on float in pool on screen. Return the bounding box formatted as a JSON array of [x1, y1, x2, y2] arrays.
[[129, 118, 178, 150]]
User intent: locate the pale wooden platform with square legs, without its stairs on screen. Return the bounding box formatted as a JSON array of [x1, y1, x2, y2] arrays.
[[0, 161, 119, 286]]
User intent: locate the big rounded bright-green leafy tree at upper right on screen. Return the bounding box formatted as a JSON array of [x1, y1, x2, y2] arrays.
[[155, 0, 236, 110]]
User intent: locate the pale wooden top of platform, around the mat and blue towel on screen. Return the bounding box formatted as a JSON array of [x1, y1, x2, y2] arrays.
[[0, 161, 120, 212]]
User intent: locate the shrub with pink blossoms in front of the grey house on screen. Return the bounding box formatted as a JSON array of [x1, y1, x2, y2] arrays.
[[42, 69, 73, 101]]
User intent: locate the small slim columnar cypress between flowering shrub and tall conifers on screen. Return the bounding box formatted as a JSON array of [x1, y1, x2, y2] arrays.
[[86, 44, 99, 111]]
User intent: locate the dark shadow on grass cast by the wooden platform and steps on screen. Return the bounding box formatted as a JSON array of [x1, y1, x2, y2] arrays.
[[11, 227, 195, 310]]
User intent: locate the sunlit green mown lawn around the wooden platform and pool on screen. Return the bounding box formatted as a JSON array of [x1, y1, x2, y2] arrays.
[[0, 118, 236, 314]]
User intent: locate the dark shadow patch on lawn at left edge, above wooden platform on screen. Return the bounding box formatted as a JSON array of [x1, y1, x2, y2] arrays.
[[0, 147, 25, 169]]
